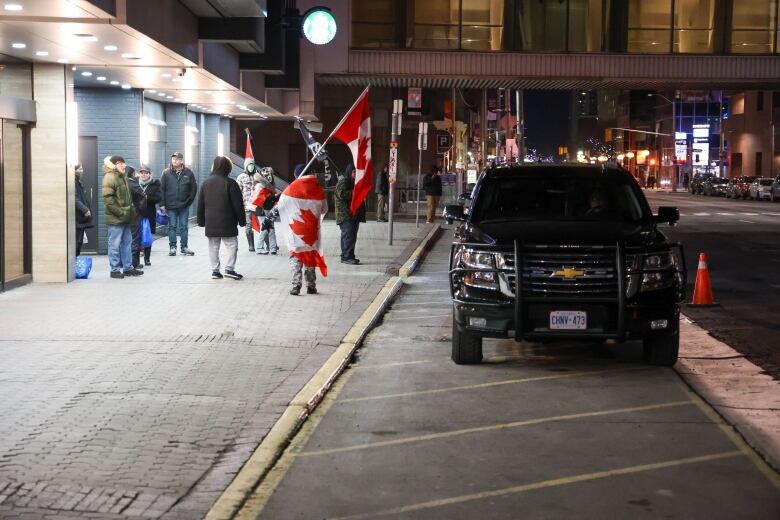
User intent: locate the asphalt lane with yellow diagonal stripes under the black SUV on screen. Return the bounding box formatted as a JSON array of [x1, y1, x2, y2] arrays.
[[239, 232, 780, 520]]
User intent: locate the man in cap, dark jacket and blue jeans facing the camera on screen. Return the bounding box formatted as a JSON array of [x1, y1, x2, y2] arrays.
[[160, 152, 198, 256]]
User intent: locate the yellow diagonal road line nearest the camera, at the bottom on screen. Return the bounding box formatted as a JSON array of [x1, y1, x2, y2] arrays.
[[331, 450, 744, 520]]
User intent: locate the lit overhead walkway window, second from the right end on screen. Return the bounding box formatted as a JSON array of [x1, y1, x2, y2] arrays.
[[674, 0, 715, 53]]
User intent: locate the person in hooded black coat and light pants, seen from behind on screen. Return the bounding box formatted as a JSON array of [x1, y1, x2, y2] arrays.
[[198, 155, 246, 280]]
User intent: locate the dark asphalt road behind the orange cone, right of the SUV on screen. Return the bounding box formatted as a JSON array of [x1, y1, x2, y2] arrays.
[[645, 190, 780, 379]]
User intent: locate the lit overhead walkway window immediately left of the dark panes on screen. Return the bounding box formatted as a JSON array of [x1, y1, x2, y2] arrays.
[[461, 0, 504, 51]]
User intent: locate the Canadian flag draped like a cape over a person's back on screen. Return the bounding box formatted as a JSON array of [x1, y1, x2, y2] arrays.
[[276, 175, 328, 276]]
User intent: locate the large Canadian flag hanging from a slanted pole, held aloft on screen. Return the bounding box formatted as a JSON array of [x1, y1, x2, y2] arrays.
[[331, 87, 371, 213]]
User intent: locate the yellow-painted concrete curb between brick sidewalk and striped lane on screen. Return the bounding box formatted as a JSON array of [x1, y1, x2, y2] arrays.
[[205, 225, 442, 520]]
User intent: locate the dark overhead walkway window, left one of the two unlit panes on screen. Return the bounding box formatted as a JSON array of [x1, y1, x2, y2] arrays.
[[518, 0, 566, 51]]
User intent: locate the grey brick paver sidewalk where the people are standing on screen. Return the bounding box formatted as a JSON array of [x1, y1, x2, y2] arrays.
[[0, 221, 429, 519]]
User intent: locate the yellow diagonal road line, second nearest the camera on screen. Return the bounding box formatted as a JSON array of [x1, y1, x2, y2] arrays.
[[298, 401, 696, 457]]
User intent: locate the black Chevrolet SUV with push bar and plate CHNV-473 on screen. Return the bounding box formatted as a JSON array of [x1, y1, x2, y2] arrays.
[[445, 165, 685, 366]]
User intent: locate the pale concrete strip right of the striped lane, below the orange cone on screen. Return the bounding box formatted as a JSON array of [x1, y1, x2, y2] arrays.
[[674, 315, 780, 480]]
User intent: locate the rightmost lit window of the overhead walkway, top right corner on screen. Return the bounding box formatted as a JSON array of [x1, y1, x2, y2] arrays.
[[731, 0, 778, 54]]
